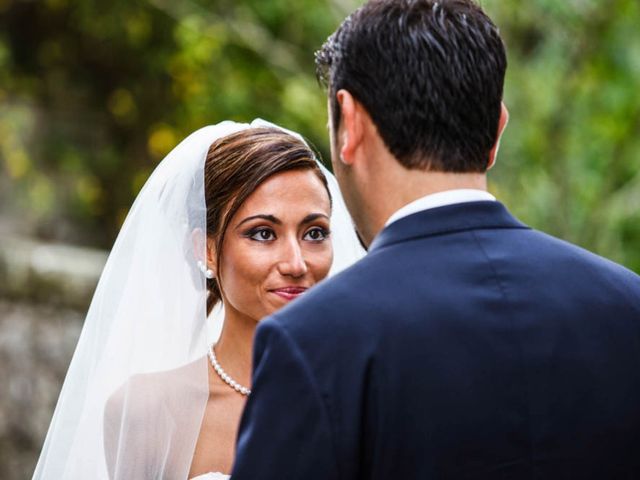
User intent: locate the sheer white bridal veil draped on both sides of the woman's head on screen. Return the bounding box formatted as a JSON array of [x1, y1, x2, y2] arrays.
[[33, 120, 364, 480]]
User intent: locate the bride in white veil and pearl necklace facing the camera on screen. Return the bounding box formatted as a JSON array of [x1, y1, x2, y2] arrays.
[[33, 120, 364, 480]]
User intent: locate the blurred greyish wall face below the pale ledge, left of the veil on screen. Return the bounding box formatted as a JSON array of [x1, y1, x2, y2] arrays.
[[0, 300, 83, 480]]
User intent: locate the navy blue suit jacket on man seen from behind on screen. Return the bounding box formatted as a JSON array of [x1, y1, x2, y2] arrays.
[[232, 202, 640, 480]]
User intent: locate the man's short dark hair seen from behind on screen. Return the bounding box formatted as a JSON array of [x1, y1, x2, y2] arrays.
[[316, 0, 507, 172]]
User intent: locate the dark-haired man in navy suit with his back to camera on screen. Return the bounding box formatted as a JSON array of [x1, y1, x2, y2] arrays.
[[233, 0, 640, 480]]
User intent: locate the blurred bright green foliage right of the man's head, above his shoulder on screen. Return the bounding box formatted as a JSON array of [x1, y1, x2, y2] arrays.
[[485, 0, 640, 272]]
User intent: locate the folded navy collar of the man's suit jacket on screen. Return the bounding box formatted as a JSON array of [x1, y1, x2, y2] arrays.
[[369, 201, 529, 252]]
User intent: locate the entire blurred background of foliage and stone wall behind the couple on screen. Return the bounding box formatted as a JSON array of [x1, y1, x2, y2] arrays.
[[0, 0, 640, 480]]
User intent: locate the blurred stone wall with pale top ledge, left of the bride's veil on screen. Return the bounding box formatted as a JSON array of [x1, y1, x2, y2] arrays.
[[0, 237, 106, 480]]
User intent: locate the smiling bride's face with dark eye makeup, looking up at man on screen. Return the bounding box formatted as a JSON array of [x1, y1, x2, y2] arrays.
[[219, 170, 333, 321]]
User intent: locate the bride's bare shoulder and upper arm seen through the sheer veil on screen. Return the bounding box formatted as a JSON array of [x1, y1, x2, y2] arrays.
[[103, 356, 208, 480]]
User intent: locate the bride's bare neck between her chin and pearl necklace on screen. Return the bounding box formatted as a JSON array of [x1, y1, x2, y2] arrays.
[[215, 306, 257, 388]]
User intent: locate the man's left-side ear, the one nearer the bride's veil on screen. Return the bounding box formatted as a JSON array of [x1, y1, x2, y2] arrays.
[[336, 89, 365, 165]]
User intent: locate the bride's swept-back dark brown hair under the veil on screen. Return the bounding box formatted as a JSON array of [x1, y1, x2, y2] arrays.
[[204, 128, 331, 314]]
